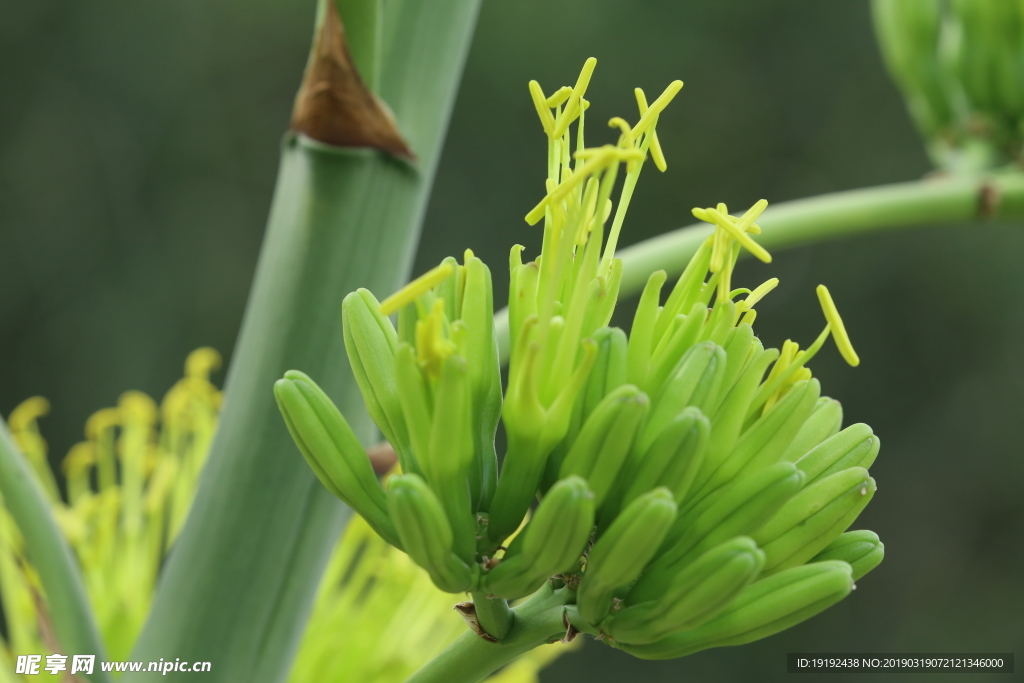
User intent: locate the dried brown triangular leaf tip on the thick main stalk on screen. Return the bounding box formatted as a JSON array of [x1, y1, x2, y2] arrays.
[[292, 2, 414, 159]]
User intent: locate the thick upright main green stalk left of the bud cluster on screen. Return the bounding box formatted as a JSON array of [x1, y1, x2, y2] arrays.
[[124, 0, 479, 683]]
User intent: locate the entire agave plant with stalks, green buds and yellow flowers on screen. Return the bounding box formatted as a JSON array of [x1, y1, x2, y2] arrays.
[[0, 0, 1024, 683]]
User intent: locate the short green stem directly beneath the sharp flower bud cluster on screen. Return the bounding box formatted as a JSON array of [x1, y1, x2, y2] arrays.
[[407, 585, 568, 683]]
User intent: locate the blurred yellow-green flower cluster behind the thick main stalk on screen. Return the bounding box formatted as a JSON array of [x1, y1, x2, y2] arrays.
[[0, 348, 564, 683]]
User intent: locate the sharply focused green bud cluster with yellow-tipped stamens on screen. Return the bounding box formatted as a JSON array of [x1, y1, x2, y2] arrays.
[[275, 60, 882, 657]]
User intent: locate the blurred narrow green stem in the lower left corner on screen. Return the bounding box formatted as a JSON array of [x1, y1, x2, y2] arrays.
[[0, 421, 110, 681]]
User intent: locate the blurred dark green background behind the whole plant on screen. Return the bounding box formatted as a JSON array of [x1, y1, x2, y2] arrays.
[[0, 0, 1024, 682]]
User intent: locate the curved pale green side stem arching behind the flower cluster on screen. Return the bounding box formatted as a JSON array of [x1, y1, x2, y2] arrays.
[[495, 173, 1024, 360]]
